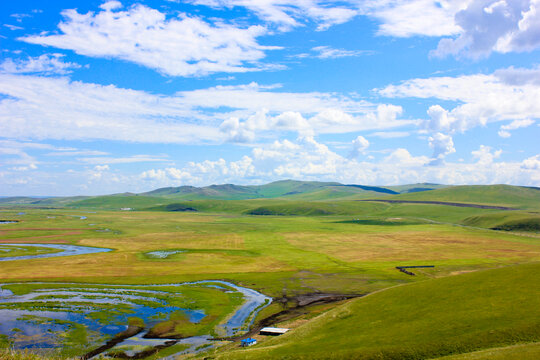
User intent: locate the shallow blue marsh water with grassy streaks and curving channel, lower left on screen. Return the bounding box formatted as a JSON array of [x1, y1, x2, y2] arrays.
[[0, 280, 271, 355]]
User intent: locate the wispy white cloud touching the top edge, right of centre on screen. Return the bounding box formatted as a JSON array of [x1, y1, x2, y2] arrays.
[[189, 0, 358, 31]]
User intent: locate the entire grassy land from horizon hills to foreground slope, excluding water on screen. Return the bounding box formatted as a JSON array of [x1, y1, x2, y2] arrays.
[[0, 181, 540, 359]]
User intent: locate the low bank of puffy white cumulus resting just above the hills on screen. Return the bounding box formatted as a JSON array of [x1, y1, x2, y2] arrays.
[[137, 137, 540, 190]]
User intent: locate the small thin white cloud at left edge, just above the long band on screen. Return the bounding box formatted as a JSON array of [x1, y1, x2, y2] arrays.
[[0, 54, 81, 75]]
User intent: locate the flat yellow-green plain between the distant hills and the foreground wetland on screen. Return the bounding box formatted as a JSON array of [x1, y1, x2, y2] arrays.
[[0, 211, 540, 296]]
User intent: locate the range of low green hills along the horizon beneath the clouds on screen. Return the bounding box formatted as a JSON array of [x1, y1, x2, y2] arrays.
[[0, 180, 540, 213]]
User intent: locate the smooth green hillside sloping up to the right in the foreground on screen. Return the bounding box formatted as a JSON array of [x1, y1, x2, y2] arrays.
[[205, 263, 540, 359]]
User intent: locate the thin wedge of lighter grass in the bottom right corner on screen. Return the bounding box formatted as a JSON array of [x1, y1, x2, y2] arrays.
[[430, 342, 540, 360]]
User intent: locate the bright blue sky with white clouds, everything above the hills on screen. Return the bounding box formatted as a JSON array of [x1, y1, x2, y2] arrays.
[[0, 0, 540, 196]]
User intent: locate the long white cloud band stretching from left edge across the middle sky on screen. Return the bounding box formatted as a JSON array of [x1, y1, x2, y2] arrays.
[[0, 74, 415, 144]]
